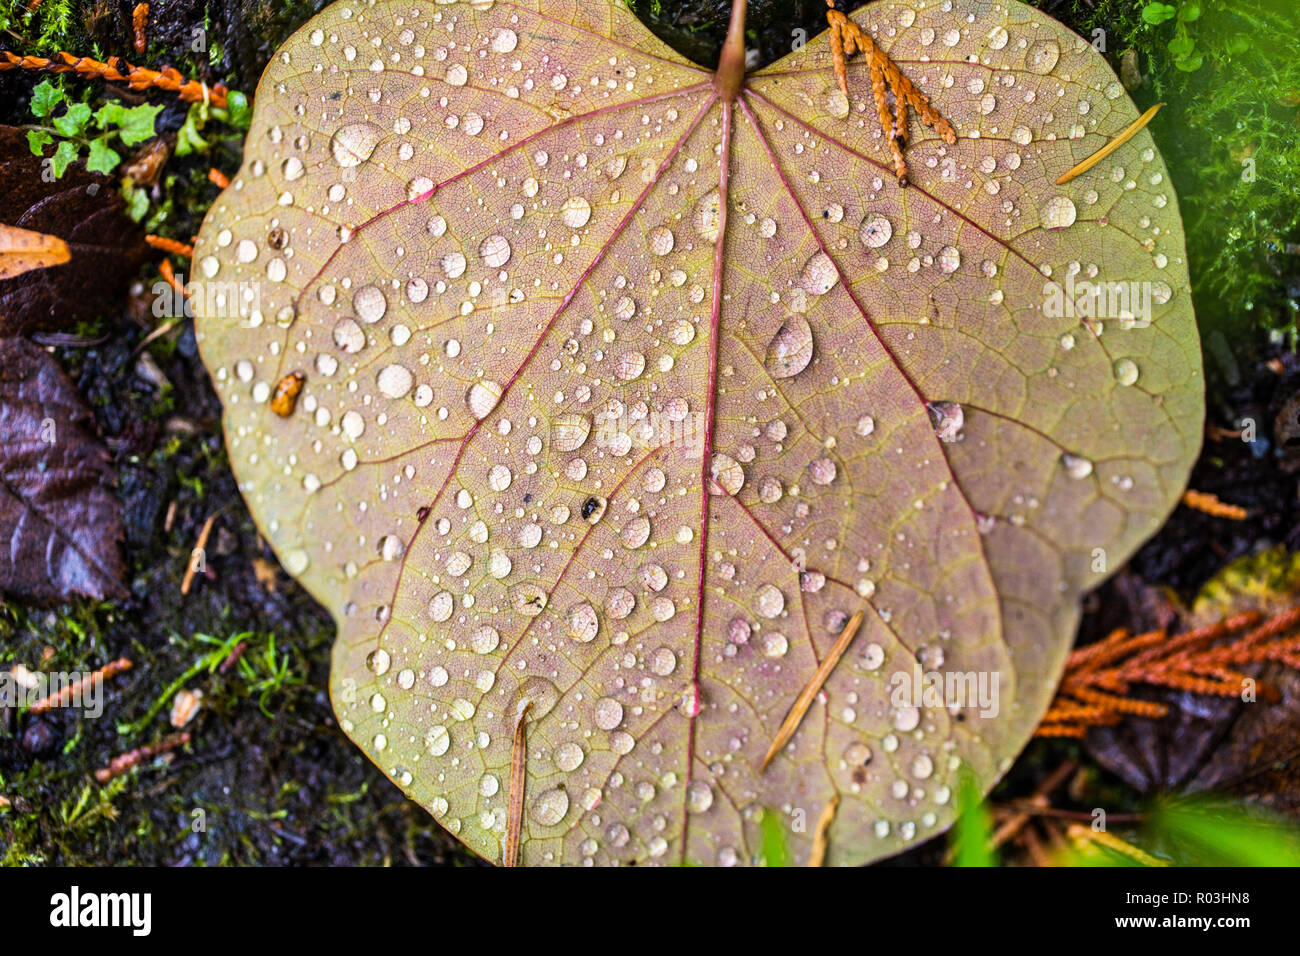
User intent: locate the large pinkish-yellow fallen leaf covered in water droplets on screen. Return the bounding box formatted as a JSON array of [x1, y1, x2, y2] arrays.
[[195, 0, 1203, 864]]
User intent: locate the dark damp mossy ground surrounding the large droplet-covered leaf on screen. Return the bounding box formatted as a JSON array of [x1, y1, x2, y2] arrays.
[[0, 0, 1300, 865]]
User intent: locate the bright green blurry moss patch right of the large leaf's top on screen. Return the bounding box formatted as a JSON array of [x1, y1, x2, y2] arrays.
[[1040, 0, 1300, 334]]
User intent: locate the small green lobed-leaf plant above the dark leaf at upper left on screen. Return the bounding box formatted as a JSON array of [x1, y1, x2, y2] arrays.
[[27, 79, 163, 179]]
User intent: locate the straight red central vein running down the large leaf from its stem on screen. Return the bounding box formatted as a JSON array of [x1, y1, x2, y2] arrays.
[[681, 100, 732, 862]]
